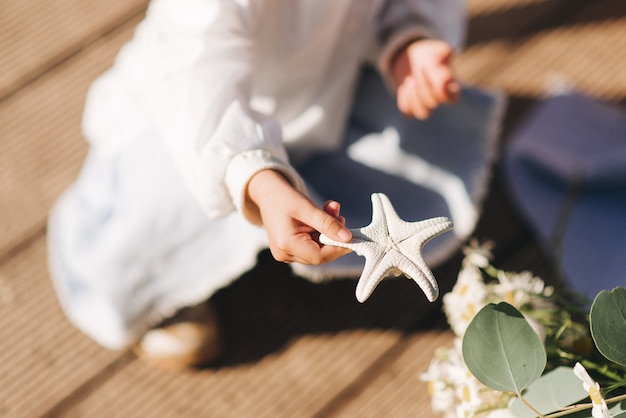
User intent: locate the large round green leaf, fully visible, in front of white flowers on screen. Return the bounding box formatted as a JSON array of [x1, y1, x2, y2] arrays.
[[463, 302, 546, 393]]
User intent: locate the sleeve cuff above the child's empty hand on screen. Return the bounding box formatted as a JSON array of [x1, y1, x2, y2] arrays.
[[372, 0, 467, 87]]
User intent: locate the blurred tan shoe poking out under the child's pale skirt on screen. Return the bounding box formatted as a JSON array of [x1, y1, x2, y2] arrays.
[[135, 302, 222, 371]]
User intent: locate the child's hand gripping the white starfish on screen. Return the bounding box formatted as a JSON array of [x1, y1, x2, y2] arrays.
[[247, 170, 352, 265]]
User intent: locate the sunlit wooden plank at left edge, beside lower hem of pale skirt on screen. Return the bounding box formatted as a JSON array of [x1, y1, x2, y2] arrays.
[[0, 239, 119, 417]]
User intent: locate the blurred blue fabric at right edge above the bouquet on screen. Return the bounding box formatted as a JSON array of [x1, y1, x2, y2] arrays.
[[504, 94, 626, 299]]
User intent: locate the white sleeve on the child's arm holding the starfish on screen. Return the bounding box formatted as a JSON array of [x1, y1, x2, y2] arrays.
[[137, 0, 305, 218]]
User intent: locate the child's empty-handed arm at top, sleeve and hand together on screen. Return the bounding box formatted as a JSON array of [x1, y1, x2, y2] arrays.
[[370, 0, 467, 119]]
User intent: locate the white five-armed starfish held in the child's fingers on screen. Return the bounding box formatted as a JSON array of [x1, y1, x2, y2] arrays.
[[320, 193, 452, 302]]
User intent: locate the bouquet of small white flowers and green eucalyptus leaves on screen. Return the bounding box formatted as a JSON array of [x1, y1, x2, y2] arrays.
[[420, 242, 626, 418]]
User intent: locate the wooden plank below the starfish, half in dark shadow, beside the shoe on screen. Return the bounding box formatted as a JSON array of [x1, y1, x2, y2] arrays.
[[56, 252, 448, 417]]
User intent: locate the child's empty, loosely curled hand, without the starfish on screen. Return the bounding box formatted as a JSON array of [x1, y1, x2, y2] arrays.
[[392, 39, 461, 119]]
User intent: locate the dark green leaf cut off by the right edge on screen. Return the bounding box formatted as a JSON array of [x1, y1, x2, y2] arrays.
[[589, 287, 626, 366]]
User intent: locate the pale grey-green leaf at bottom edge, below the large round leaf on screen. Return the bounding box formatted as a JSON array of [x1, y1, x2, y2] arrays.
[[511, 367, 589, 418]]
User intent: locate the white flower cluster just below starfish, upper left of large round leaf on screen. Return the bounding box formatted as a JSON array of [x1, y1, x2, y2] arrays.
[[443, 265, 487, 336]]
